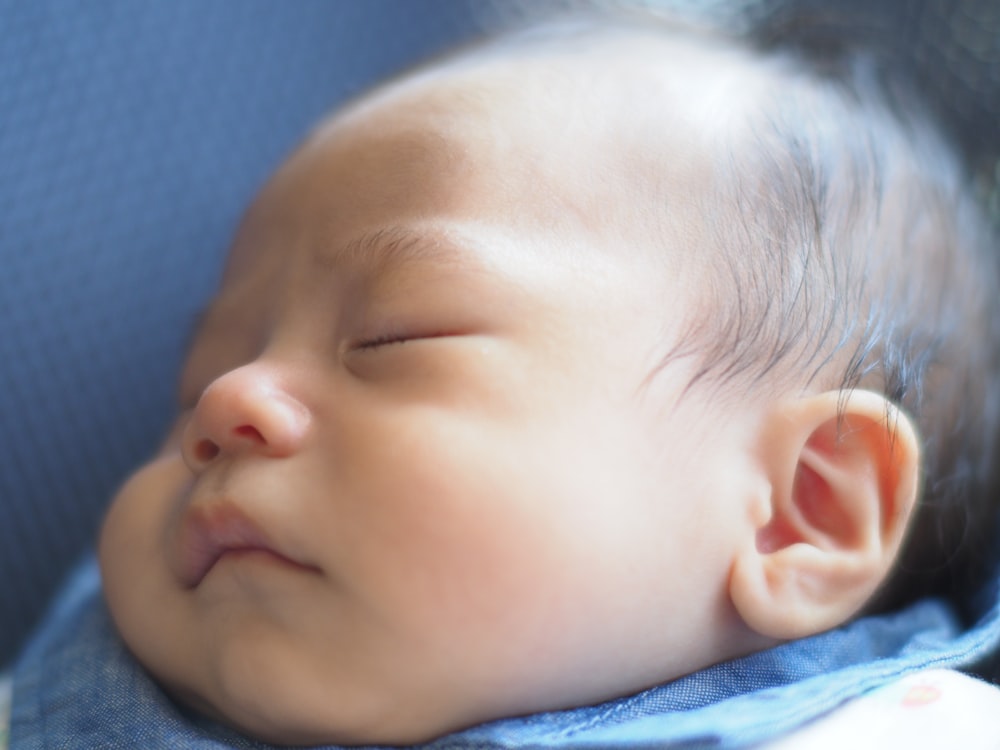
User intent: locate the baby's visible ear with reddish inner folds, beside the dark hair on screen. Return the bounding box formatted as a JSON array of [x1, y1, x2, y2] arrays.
[[729, 391, 920, 640]]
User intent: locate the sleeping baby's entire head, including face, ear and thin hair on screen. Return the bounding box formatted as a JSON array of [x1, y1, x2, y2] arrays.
[[101, 10, 995, 743]]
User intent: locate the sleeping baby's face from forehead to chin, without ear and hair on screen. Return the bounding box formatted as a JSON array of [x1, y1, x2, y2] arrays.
[[101, 33, 764, 743]]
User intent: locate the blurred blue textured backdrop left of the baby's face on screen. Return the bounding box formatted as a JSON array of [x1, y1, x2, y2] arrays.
[[0, 0, 484, 664]]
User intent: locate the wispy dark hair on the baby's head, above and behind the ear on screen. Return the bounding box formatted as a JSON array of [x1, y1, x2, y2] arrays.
[[476, 3, 1000, 616]]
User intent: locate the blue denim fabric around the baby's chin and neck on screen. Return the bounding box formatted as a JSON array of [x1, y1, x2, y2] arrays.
[[11, 560, 1000, 750]]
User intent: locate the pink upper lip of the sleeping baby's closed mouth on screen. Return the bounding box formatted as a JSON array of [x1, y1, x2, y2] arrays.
[[177, 502, 315, 588]]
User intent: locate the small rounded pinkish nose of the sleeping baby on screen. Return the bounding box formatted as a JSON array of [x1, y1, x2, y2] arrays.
[[181, 363, 312, 472]]
